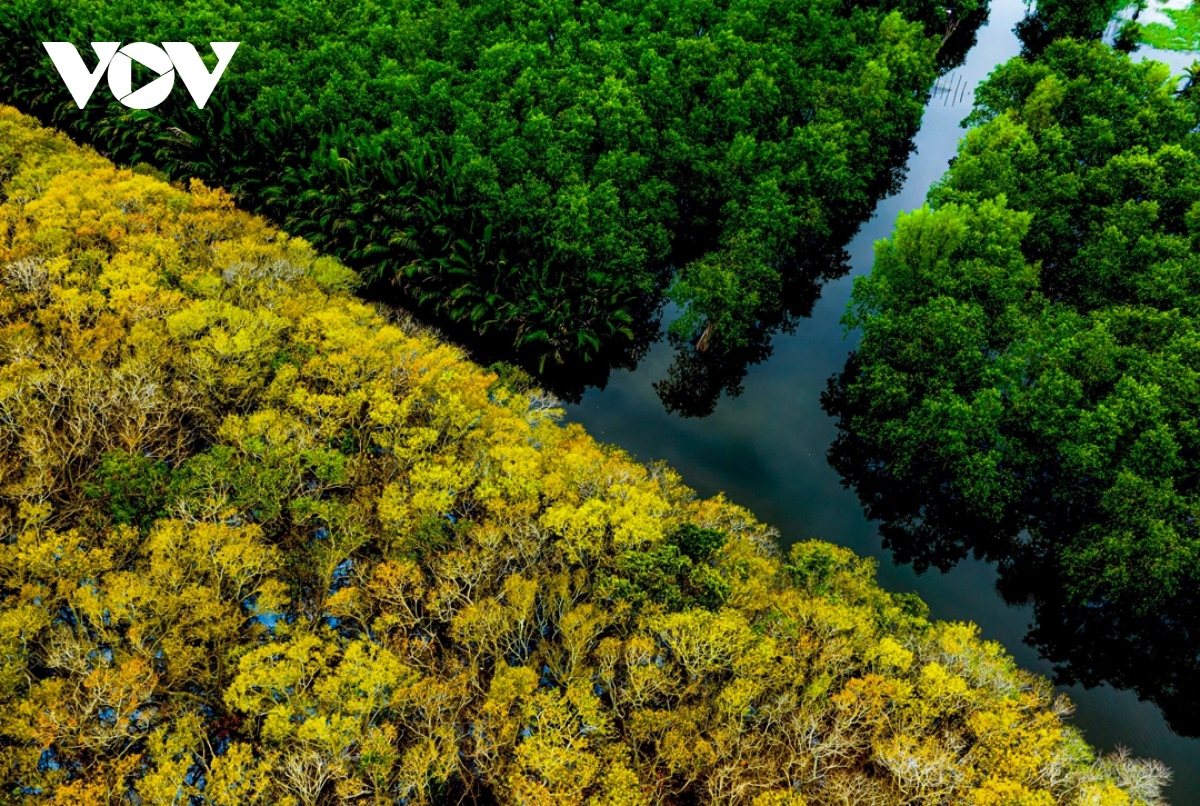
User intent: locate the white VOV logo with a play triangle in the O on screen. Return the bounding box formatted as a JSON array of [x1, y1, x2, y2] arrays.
[[42, 42, 240, 109]]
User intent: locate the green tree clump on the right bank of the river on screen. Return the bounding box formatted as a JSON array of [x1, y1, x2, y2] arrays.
[[826, 41, 1200, 733]]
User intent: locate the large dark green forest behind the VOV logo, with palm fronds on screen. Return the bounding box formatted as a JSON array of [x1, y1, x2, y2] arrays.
[[0, 0, 964, 400]]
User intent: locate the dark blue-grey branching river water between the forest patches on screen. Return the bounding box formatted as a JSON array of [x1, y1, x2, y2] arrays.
[[568, 0, 1200, 806]]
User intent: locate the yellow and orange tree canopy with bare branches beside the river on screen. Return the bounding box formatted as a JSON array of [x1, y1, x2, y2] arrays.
[[0, 108, 1164, 806]]
